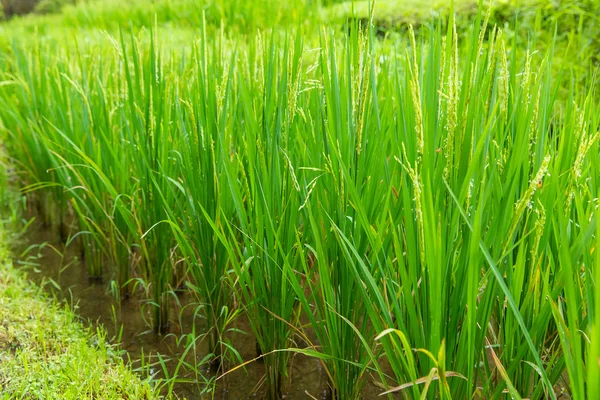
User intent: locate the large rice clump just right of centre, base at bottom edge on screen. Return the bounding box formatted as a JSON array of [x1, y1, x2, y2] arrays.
[[282, 20, 394, 399]]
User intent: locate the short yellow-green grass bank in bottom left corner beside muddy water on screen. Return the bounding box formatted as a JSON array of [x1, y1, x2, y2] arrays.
[[0, 232, 158, 399]]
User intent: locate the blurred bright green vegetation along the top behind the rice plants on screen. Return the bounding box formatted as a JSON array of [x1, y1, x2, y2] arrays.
[[0, 0, 600, 100]]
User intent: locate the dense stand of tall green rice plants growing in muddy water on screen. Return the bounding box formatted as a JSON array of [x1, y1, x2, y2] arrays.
[[0, 3, 600, 399]]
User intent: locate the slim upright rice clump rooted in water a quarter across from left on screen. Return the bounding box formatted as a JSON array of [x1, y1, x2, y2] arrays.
[[115, 29, 183, 332]]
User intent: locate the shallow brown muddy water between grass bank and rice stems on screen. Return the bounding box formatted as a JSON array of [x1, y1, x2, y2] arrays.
[[15, 224, 379, 400]]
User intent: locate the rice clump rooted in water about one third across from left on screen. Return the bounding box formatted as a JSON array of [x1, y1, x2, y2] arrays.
[[159, 17, 239, 366]]
